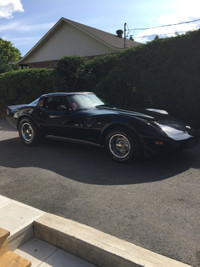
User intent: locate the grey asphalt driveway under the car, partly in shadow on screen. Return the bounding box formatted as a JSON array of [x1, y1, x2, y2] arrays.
[[0, 120, 200, 266]]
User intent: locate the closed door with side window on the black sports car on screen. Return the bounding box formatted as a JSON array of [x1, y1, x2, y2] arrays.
[[38, 96, 101, 142]]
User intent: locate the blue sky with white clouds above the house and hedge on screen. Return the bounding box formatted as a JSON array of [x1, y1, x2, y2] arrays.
[[0, 0, 200, 56]]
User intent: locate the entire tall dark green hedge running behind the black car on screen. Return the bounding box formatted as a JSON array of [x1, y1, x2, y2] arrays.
[[0, 31, 200, 128]]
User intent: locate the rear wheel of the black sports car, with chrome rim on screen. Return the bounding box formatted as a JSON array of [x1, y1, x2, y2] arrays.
[[18, 118, 42, 146]]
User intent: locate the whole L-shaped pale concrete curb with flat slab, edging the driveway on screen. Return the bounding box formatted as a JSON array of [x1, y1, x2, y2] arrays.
[[0, 195, 191, 267]]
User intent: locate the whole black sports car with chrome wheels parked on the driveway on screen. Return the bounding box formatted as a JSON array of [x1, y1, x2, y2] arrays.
[[7, 92, 199, 161]]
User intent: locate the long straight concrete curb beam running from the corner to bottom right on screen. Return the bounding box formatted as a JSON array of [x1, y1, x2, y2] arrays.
[[34, 213, 190, 267]]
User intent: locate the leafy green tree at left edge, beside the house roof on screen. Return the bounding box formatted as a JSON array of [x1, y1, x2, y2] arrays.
[[0, 38, 21, 73]]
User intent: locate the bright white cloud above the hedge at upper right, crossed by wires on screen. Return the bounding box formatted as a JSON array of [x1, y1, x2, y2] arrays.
[[134, 0, 200, 42]]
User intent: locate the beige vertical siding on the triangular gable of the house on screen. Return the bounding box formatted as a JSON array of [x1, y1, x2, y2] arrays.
[[24, 23, 116, 63]]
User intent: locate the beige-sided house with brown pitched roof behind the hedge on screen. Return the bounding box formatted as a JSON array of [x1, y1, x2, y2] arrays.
[[17, 18, 139, 68]]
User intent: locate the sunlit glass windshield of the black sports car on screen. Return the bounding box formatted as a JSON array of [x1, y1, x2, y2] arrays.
[[68, 94, 104, 110]]
